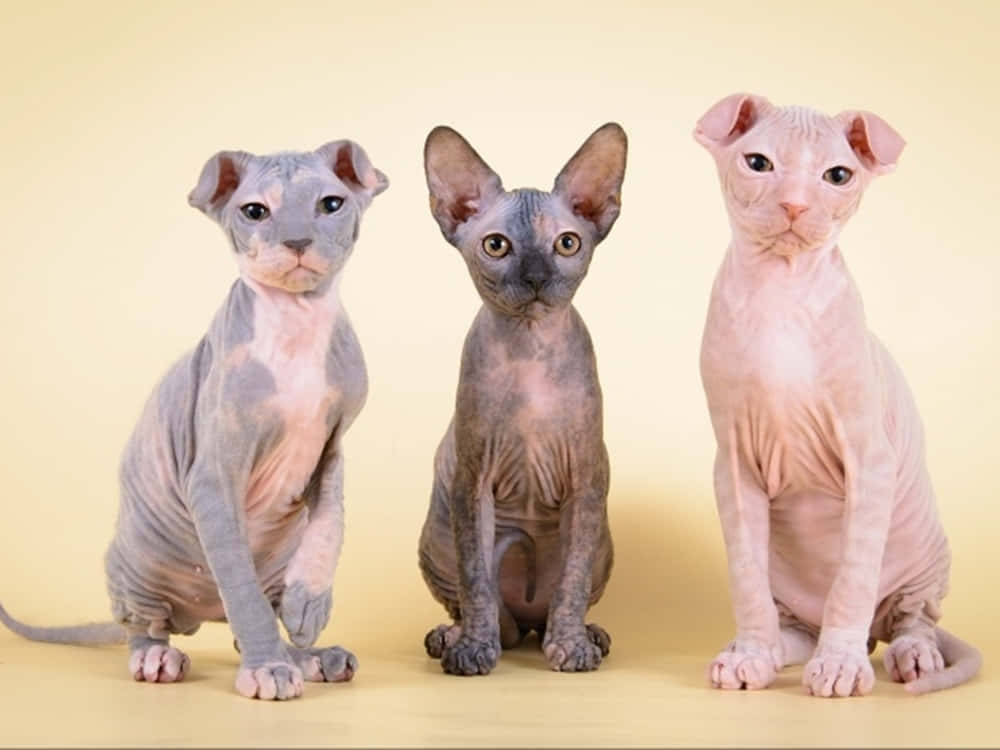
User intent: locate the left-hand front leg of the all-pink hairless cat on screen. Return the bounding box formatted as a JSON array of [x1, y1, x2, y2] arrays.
[[709, 440, 785, 690]]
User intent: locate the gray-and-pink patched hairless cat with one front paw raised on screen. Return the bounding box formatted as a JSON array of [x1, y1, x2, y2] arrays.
[[0, 140, 388, 700]]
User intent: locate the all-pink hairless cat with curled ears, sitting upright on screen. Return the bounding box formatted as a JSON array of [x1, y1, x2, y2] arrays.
[[694, 94, 981, 696]]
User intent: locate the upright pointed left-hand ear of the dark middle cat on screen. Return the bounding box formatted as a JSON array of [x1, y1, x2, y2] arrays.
[[424, 125, 503, 242]]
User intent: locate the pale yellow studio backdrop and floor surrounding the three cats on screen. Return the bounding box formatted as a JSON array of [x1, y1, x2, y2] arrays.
[[0, 0, 1000, 746]]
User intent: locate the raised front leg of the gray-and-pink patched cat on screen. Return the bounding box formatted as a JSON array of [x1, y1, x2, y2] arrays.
[[279, 449, 344, 648]]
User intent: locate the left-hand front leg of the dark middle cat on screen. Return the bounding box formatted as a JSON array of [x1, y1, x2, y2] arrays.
[[441, 459, 501, 675]]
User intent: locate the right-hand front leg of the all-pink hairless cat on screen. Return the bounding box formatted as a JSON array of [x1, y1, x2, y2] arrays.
[[802, 418, 896, 698]]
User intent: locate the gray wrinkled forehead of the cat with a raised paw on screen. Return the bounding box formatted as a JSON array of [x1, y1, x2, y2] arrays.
[[237, 153, 347, 210]]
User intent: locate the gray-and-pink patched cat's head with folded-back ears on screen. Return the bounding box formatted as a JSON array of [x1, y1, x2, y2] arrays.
[[188, 140, 389, 293]]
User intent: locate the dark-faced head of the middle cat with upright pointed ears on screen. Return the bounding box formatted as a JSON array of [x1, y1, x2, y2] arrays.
[[424, 123, 627, 320]]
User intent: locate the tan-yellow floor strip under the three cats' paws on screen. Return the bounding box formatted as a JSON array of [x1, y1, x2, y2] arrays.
[[0, 625, 1000, 747]]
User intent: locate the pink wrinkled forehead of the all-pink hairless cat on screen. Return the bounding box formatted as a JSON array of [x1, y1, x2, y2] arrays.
[[737, 107, 855, 163]]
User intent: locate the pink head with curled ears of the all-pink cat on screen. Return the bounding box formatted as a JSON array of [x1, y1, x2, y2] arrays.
[[694, 94, 905, 258]]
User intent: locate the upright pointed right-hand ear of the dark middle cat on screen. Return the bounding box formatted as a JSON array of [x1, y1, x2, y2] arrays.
[[552, 122, 628, 241]]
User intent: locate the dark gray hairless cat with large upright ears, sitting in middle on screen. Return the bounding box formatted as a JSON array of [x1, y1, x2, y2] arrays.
[[420, 123, 627, 675]]
